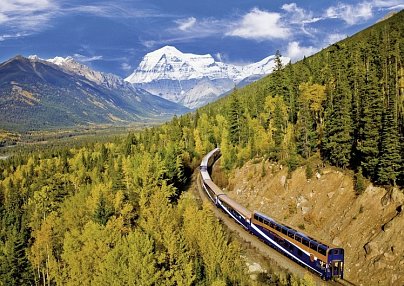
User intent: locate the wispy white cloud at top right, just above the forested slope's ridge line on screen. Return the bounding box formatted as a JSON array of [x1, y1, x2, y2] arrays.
[[326, 2, 373, 25]]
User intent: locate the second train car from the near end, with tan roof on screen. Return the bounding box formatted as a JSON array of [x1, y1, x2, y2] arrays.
[[217, 194, 252, 230]]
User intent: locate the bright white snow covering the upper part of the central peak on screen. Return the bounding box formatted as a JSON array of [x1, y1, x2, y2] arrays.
[[125, 46, 289, 84]]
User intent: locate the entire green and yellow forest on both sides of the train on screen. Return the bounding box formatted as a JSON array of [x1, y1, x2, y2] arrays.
[[0, 9, 404, 285]]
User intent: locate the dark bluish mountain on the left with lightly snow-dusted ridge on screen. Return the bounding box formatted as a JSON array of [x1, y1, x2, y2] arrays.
[[0, 56, 189, 130]]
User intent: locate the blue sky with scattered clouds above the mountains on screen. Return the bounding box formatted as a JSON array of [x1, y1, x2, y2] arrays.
[[0, 0, 404, 76]]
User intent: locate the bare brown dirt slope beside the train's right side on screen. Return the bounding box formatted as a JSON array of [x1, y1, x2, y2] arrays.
[[221, 162, 404, 285]]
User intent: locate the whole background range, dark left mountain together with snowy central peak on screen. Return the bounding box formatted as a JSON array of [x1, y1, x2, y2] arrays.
[[0, 46, 289, 130]]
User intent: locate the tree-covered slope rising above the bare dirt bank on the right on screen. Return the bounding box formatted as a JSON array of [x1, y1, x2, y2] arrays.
[[198, 11, 404, 185]]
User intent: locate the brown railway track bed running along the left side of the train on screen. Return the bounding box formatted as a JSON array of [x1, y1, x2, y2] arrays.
[[193, 172, 355, 286]]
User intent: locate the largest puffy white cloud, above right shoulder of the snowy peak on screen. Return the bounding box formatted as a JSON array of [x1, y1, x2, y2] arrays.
[[226, 8, 291, 40]]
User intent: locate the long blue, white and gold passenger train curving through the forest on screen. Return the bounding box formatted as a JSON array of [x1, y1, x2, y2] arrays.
[[199, 148, 344, 280]]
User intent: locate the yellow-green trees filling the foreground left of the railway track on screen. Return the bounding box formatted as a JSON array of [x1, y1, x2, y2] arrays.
[[0, 139, 252, 285]]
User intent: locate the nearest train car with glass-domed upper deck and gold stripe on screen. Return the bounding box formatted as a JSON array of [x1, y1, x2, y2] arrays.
[[251, 212, 344, 280]]
